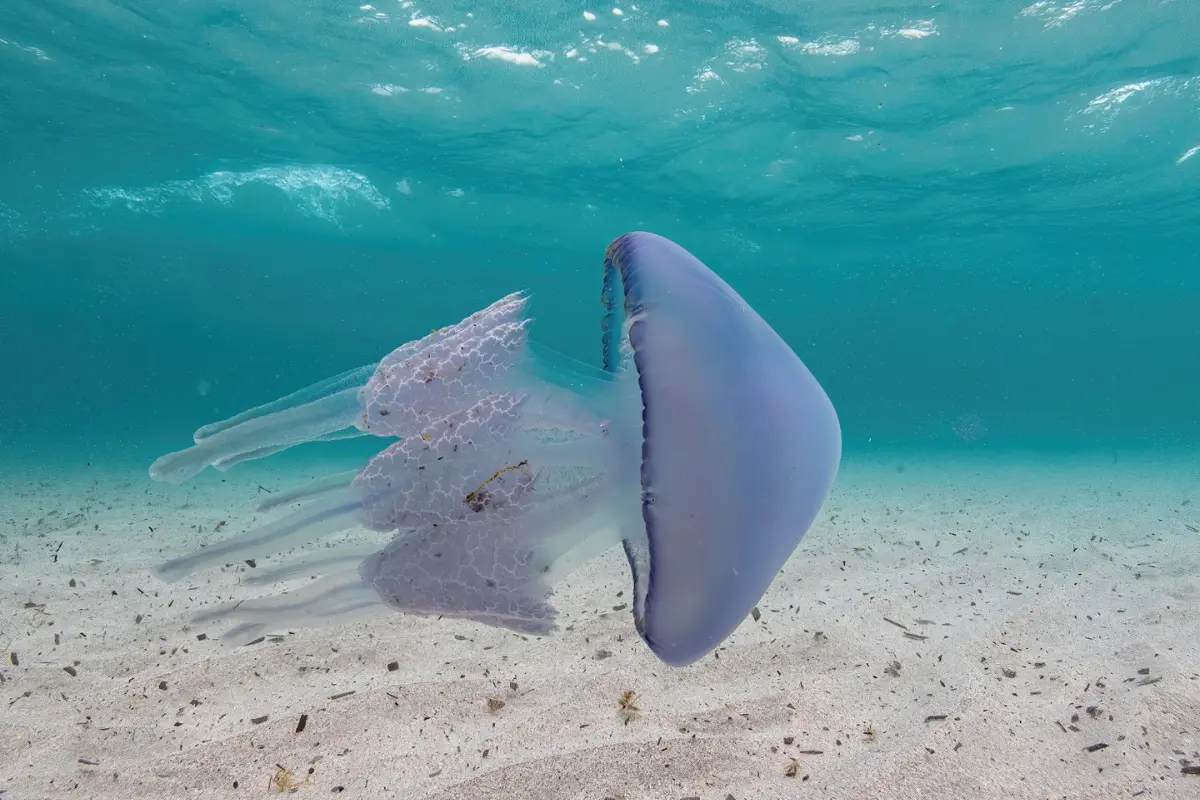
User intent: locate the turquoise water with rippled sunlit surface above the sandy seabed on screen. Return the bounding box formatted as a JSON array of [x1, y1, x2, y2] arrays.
[[0, 0, 1200, 462]]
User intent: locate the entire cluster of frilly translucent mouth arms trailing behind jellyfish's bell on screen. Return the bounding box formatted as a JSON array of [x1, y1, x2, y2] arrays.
[[151, 293, 667, 640]]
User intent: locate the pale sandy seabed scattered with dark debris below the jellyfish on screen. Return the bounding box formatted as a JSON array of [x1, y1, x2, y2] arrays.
[[0, 456, 1200, 800]]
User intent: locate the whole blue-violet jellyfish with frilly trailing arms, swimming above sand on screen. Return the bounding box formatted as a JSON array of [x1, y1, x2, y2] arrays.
[[150, 233, 841, 667]]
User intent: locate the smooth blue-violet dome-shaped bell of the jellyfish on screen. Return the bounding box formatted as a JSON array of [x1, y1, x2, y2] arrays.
[[605, 233, 841, 664]]
